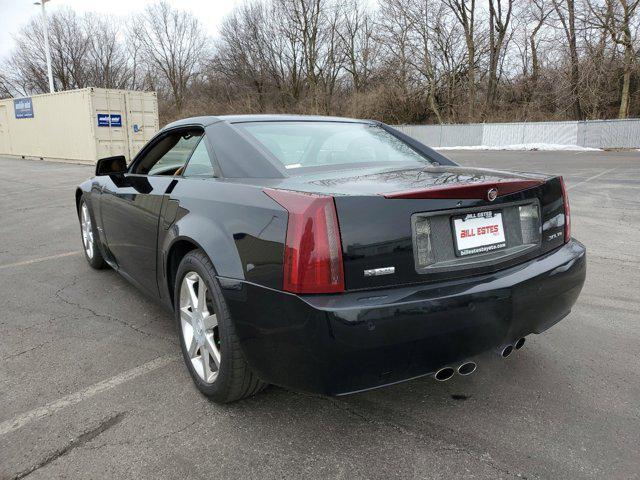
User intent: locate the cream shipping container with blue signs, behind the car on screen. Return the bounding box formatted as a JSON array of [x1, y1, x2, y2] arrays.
[[0, 88, 159, 163]]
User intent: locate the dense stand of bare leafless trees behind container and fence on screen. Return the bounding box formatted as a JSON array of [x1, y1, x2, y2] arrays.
[[0, 0, 640, 123]]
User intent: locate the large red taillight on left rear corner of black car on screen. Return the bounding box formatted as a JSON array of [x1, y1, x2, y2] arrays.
[[264, 188, 344, 293]]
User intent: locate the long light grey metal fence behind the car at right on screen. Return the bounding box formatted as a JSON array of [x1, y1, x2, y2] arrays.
[[396, 119, 640, 148]]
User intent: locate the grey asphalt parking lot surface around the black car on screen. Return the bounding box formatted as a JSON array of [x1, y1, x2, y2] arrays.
[[0, 152, 640, 480]]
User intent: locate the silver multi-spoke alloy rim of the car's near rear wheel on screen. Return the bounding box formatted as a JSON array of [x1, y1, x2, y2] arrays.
[[179, 271, 220, 383]]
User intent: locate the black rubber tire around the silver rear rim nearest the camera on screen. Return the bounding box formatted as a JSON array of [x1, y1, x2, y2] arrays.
[[174, 250, 267, 403]]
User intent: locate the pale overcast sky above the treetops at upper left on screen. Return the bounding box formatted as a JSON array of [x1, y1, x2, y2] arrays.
[[0, 0, 243, 59]]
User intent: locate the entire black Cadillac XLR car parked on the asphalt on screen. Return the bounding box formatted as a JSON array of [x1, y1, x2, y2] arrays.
[[76, 115, 586, 402]]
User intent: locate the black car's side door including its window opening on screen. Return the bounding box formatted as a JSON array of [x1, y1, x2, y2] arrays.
[[100, 129, 202, 295]]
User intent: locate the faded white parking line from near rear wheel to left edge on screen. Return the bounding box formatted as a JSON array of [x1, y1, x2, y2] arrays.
[[0, 354, 179, 435]]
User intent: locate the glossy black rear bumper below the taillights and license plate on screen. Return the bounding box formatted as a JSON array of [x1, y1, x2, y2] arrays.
[[220, 240, 586, 395]]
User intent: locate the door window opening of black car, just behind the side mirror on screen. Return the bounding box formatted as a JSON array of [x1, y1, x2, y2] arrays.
[[132, 130, 202, 175]]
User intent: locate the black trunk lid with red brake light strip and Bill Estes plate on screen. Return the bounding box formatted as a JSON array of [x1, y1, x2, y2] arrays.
[[323, 167, 564, 290]]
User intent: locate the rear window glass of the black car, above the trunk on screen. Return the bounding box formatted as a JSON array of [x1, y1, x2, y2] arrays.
[[235, 122, 429, 169]]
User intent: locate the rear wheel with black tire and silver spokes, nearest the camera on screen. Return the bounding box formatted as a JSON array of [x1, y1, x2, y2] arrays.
[[174, 250, 266, 403]]
